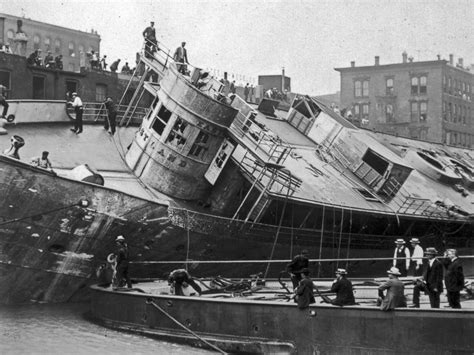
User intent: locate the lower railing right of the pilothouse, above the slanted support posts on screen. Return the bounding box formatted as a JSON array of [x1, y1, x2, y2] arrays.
[[233, 150, 302, 196]]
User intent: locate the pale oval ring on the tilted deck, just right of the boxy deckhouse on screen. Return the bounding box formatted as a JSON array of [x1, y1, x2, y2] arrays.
[[405, 150, 462, 185]]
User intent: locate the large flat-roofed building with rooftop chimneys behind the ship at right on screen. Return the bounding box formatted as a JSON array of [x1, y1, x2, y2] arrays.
[[335, 53, 474, 148]]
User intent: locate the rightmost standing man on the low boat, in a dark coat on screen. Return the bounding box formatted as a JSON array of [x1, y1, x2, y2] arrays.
[[443, 249, 464, 308]]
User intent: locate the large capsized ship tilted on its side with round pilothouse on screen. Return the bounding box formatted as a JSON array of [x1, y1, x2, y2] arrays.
[[0, 45, 474, 303]]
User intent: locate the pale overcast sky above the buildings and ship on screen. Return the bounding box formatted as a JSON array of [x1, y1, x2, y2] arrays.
[[0, 0, 474, 94]]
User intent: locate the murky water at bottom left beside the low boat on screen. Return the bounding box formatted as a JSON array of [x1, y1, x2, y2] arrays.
[[0, 304, 211, 355]]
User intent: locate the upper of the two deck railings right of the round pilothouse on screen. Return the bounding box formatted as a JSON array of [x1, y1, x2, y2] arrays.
[[229, 112, 292, 164]]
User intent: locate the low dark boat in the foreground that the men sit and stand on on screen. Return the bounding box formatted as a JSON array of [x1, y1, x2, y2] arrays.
[[90, 280, 474, 354]]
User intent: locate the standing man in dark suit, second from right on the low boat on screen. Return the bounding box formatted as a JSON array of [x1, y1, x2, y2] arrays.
[[410, 248, 443, 308]]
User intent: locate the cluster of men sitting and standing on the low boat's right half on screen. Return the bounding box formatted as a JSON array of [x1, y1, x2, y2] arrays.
[[287, 243, 464, 311]]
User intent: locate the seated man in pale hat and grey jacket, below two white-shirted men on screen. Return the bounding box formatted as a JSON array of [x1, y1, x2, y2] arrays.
[[377, 267, 407, 311]]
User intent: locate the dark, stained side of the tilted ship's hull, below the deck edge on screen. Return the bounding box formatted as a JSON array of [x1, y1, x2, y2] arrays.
[[0, 157, 469, 304]]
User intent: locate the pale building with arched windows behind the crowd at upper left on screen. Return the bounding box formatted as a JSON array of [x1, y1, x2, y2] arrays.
[[0, 13, 100, 71]]
